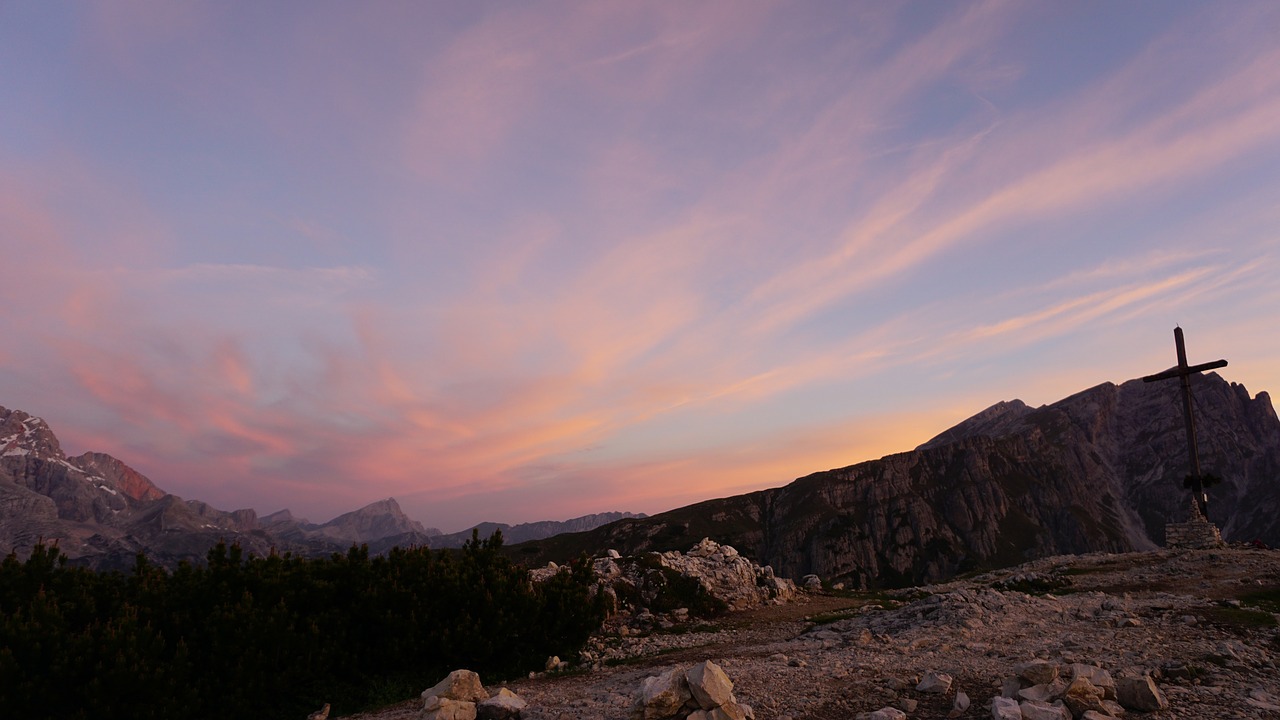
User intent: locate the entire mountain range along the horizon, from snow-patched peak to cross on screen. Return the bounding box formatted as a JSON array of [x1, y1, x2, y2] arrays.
[[0, 373, 1280, 579]]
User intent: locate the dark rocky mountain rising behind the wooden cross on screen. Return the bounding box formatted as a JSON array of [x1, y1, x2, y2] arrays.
[[526, 374, 1280, 584]]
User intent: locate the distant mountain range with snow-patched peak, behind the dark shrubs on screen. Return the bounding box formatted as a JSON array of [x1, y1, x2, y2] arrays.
[[0, 407, 643, 569]]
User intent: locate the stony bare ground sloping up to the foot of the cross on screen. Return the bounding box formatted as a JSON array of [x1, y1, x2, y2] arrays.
[[352, 547, 1280, 720]]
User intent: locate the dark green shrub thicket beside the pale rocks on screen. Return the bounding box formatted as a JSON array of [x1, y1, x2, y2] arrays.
[[0, 534, 605, 720]]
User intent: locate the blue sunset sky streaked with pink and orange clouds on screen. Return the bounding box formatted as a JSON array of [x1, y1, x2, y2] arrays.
[[0, 0, 1280, 532]]
